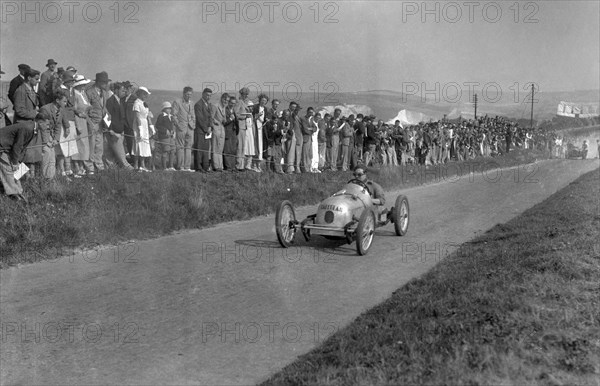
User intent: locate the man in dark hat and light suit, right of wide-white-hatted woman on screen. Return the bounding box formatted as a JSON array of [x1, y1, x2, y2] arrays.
[[83, 71, 110, 173]]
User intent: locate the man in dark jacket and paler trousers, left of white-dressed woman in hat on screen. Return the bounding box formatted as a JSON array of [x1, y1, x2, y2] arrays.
[[104, 83, 133, 169]]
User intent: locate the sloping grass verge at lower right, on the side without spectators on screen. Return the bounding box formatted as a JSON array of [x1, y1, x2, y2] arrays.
[[264, 170, 600, 385]]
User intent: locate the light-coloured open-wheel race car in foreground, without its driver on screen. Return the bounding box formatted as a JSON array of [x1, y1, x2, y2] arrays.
[[275, 179, 409, 255]]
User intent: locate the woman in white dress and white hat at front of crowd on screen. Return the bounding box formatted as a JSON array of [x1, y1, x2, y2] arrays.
[[133, 87, 154, 172]]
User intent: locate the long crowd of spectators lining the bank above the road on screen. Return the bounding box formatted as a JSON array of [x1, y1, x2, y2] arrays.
[[0, 59, 592, 199]]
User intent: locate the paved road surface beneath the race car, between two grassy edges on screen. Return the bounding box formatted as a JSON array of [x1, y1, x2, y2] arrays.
[[0, 160, 599, 385]]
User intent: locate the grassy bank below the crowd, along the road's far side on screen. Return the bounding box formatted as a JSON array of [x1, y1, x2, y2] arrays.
[[0, 151, 545, 268]]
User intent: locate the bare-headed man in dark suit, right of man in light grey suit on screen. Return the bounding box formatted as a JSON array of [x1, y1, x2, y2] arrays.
[[194, 88, 214, 173]]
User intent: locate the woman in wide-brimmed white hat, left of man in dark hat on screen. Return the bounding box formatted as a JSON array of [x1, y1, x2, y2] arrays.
[[71, 75, 94, 177]]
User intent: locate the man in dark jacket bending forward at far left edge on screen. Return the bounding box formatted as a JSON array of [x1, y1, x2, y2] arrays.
[[0, 113, 49, 202]]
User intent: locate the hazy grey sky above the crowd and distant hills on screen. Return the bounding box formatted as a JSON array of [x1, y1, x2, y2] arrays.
[[0, 0, 600, 95]]
